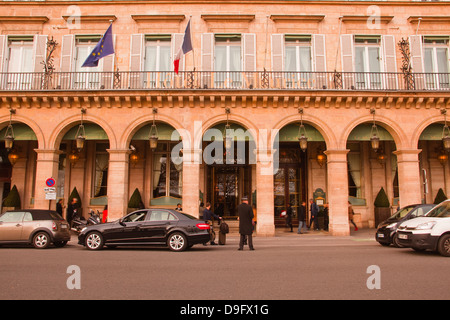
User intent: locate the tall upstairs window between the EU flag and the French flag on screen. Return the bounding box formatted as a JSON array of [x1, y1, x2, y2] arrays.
[[144, 34, 172, 88]]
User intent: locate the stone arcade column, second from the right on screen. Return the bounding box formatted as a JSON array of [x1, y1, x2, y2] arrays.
[[325, 149, 350, 236]]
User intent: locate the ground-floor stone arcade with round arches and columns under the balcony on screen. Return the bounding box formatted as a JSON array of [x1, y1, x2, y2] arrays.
[[0, 92, 450, 236]]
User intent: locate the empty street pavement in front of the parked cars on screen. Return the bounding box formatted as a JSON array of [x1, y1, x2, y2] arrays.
[[0, 229, 450, 301]]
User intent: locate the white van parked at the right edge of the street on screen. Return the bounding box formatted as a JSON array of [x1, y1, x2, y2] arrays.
[[397, 200, 450, 257]]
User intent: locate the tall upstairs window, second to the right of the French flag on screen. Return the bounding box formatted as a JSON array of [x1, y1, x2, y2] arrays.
[[284, 34, 312, 88]]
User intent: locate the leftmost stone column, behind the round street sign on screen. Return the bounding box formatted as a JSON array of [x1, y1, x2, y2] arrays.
[[34, 149, 62, 210]]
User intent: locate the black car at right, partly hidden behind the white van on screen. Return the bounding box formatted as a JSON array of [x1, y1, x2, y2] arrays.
[[375, 204, 435, 248]]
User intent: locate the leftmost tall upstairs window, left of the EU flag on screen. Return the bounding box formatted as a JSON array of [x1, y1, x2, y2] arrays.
[[7, 36, 34, 90]]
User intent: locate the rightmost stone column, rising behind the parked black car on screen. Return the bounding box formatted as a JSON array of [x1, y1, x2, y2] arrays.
[[394, 149, 423, 207]]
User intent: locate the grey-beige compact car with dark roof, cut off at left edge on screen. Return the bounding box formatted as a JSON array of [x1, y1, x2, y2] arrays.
[[0, 210, 70, 249]]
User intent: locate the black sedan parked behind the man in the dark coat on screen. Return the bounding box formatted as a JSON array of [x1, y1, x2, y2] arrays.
[[78, 209, 210, 251]]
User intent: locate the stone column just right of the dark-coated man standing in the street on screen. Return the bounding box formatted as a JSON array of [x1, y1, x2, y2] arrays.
[[255, 149, 275, 236]]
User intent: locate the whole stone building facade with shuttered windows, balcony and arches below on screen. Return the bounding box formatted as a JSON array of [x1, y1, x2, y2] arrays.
[[0, 0, 450, 236]]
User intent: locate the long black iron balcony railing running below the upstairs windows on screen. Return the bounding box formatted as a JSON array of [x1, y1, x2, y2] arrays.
[[0, 71, 450, 91]]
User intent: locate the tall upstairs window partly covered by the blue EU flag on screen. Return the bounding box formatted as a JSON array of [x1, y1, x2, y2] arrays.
[[75, 35, 103, 89]]
